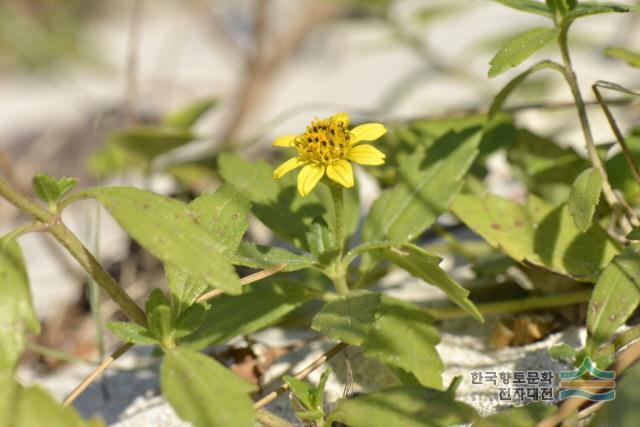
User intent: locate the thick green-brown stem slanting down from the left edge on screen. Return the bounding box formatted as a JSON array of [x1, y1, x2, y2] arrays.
[[0, 178, 147, 325]]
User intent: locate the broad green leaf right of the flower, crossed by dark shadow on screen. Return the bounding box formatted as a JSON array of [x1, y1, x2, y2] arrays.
[[362, 127, 481, 246]]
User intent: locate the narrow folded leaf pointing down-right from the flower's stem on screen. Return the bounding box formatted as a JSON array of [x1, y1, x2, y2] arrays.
[[373, 244, 484, 322]]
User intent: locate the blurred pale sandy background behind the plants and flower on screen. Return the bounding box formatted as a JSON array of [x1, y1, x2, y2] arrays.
[[0, 0, 640, 424]]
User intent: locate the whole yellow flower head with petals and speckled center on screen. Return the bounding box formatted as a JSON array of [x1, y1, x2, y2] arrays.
[[273, 113, 387, 197]]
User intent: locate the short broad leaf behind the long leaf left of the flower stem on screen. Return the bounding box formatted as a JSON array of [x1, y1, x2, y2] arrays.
[[189, 184, 251, 255]]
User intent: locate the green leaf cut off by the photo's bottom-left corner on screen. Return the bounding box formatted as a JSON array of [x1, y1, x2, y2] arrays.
[[0, 375, 105, 427]]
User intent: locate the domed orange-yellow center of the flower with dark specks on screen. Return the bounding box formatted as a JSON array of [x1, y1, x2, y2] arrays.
[[293, 118, 351, 166]]
